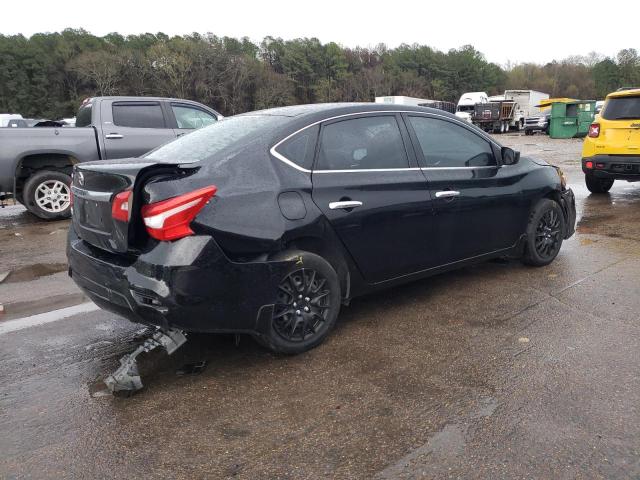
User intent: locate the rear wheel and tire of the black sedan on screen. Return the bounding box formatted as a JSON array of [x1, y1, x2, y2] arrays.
[[256, 250, 341, 355]]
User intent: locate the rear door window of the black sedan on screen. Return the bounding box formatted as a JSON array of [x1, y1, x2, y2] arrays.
[[316, 116, 409, 170]]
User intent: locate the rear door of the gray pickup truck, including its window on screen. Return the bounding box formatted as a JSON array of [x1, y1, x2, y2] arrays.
[[101, 101, 176, 159]]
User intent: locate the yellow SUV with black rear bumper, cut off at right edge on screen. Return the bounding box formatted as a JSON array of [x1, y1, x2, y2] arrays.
[[582, 88, 640, 193]]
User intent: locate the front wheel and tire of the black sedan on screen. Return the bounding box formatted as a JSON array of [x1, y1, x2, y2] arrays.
[[522, 198, 565, 267]]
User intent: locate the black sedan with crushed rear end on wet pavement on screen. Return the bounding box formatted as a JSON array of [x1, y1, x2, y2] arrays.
[[67, 104, 575, 353]]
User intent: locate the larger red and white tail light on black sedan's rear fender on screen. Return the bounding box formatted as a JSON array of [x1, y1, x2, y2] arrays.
[[142, 185, 217, 241]]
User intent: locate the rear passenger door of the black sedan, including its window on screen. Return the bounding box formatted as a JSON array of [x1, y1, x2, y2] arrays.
[[312, 113, 436, 283]]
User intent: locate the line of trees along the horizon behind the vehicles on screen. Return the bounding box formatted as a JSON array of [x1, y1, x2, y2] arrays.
[[0, 29, 640, 118]]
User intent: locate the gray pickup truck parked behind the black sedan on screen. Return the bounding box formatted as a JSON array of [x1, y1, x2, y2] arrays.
[[0, 97, 222, 220]]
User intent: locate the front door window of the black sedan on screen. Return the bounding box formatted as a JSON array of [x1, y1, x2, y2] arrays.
[[409, 117, 496, 167]]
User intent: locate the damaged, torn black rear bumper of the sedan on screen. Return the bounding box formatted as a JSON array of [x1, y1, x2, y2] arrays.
[[67, 226, 290, 334]]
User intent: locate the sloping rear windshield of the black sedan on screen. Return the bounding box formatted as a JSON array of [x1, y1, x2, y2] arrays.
[[145, 115, 288, 163]]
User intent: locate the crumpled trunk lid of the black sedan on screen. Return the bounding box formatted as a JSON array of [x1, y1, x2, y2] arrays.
[[71, 158, 182, 253]]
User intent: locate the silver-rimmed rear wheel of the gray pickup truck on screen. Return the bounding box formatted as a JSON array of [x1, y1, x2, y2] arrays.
[[22, 170, 71, 220]]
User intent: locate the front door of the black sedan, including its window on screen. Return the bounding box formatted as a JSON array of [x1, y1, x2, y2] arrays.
[[406, 114, 528, 263]]
